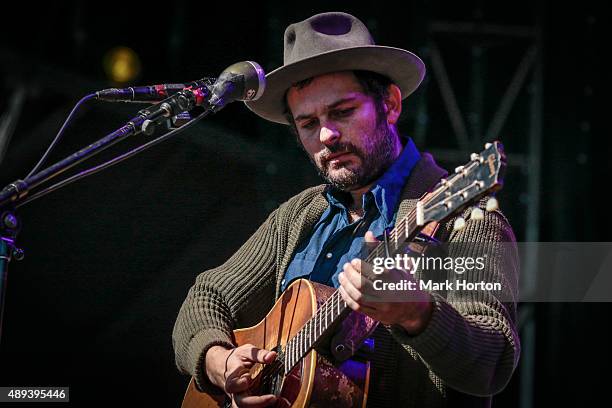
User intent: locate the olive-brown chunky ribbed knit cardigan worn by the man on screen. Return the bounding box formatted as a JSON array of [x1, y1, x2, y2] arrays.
[[172, 153, 520, 407]]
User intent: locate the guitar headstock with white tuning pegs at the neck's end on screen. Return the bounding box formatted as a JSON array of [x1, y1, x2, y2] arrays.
[[416, 141, 506, 229]]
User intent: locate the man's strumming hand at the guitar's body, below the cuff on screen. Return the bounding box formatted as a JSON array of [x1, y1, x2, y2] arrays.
[[205, 344, 276, 408]]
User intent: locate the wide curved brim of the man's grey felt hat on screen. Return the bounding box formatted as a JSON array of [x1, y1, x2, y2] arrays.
[[245, 45, 425, 125]]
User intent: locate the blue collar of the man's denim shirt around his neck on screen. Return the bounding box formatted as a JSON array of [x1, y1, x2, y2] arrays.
[[326, 138, 421, 225]]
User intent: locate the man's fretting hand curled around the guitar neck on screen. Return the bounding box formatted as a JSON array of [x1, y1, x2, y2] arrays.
[[338, 231, 432, 335]]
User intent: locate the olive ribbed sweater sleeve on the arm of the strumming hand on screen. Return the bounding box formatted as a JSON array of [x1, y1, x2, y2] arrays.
[[172, 210, 278, 394]]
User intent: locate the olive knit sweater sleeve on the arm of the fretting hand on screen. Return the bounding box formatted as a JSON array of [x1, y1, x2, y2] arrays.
[[390, 202, 520, 396]]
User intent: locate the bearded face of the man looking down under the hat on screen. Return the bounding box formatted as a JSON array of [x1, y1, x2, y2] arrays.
[[287, 72, 401, 191]]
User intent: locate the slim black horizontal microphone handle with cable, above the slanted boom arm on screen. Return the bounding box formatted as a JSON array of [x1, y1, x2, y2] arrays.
[[95, 78, 215, 103]]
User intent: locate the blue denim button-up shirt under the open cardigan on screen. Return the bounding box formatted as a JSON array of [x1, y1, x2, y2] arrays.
[[282, 139, 421, 291]]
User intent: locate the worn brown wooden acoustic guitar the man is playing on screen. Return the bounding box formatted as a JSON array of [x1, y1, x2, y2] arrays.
[[182, 141, 506, 408]]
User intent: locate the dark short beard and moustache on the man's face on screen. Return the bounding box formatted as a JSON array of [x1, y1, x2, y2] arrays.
[[311, 121, 397, 191]]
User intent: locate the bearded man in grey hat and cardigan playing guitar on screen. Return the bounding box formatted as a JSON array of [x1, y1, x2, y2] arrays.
[[173, 13, 520, 406]]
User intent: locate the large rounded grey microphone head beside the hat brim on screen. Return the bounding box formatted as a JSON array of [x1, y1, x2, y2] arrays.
[[208, 61, 266, 112]]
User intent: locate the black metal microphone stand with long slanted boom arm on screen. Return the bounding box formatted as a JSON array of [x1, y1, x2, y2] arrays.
[[0, 81, 214, 340]]
